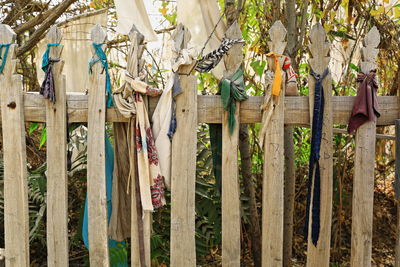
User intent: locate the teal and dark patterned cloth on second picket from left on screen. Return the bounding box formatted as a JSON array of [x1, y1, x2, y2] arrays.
[[40, 43, 60, 103]]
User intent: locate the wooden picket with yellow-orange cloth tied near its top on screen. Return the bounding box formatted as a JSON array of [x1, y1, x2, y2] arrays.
[[261, 21, 286, 266]]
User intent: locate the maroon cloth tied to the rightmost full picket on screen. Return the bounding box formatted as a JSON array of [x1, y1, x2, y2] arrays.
[[347, 70, 380, 133]]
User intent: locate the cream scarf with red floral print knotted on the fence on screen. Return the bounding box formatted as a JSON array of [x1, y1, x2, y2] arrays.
[[114, 73, 165, 214]]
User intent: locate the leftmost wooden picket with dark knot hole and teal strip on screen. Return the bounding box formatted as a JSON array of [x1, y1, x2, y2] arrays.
[[0, 24, 29, 267]]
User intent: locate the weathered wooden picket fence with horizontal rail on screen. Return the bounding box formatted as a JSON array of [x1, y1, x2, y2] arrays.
[[0, 18, 400, 267]]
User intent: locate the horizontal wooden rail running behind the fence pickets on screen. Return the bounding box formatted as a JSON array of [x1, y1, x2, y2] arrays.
[[15, 92, 400, 127]]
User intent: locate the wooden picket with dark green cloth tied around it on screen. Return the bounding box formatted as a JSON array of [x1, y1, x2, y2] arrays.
[[222, 22, 243, 267]]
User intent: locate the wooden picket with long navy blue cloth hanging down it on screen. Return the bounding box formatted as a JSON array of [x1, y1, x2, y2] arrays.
[[307, 23, 333, 267]]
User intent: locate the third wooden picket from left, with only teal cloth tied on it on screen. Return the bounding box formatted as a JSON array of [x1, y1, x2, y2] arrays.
[[87, 24, 109, 267]]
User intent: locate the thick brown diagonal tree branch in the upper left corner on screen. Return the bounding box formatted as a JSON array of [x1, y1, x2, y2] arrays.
[[17, 0, 77, 56]]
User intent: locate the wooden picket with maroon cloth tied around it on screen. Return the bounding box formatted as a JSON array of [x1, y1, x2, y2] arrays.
[[351, 27, 380, 267]]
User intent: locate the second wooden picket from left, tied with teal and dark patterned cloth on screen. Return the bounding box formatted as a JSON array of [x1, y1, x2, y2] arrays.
[[45, 26, 68, 266]]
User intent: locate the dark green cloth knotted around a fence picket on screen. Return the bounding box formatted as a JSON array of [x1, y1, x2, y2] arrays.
[[219, 68, 249, 135]]
